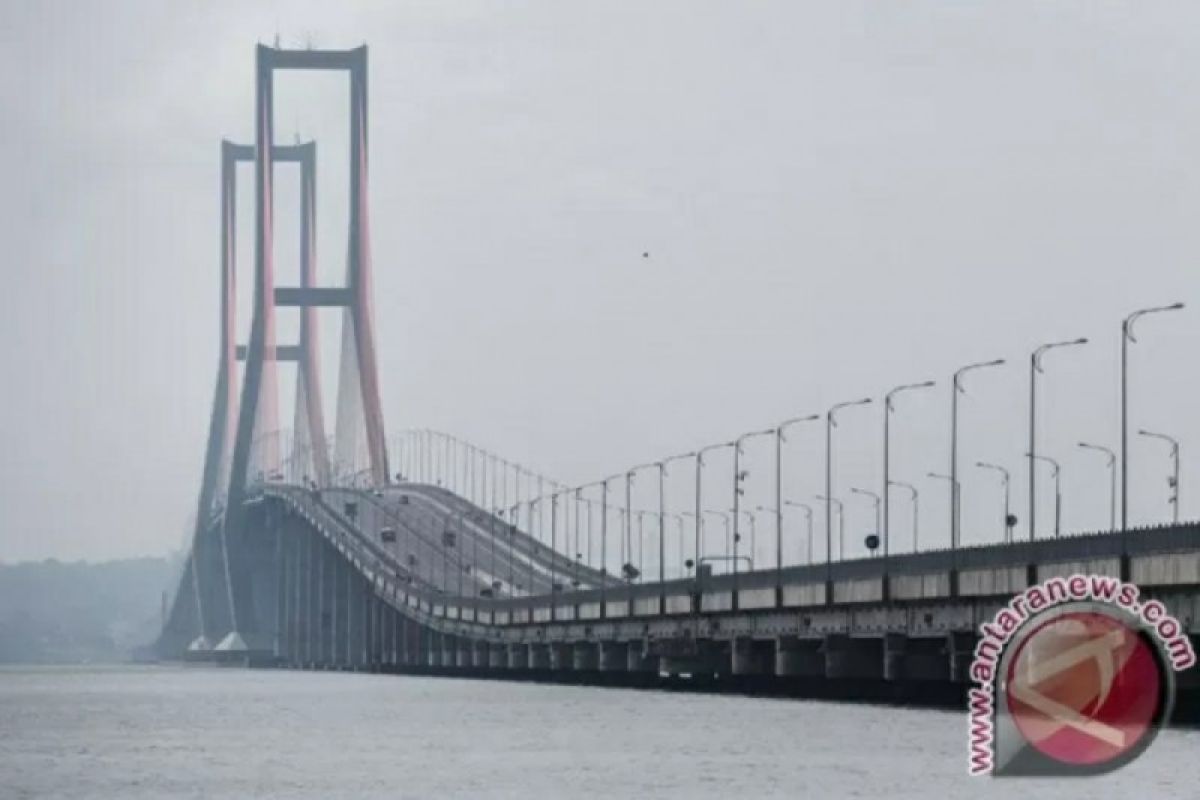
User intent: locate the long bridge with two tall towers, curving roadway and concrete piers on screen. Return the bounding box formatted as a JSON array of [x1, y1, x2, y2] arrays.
[[157, 46, 1200, 693]]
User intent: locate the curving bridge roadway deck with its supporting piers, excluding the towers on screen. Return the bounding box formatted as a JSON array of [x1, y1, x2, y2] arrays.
[[160, 474, 1200, 696]]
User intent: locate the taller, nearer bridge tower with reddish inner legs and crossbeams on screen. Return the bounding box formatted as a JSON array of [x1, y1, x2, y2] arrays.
[[218, 44, 389, 650]]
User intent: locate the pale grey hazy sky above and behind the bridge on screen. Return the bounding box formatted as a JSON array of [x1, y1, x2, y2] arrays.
[[0, 0, 1200, 561]]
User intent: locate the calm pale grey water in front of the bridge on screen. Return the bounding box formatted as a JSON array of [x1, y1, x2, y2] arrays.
[[0, 667, 1200, 800]]
